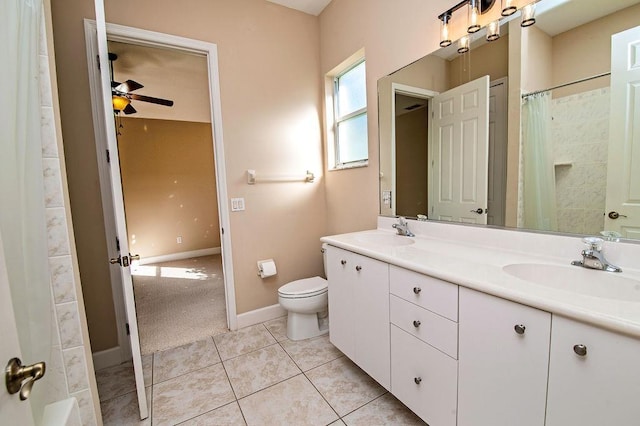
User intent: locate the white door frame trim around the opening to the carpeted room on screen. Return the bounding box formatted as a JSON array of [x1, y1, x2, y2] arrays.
[[85, 20, 237, 366]]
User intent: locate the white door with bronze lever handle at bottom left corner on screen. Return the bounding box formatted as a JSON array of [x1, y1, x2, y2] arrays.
[[0, 235, 38, 426]]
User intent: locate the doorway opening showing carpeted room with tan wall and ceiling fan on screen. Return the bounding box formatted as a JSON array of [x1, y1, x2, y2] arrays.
[[108, 41, 228, 355]]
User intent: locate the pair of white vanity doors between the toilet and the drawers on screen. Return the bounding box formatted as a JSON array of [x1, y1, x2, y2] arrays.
[[326, 246, 391, 389]]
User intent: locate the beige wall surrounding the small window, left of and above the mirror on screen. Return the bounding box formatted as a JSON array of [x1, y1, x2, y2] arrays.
[[320, 0, 451, 233]]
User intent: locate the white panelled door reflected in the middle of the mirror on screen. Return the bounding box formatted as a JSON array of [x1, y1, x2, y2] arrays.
[[429, 76, 489, 224]]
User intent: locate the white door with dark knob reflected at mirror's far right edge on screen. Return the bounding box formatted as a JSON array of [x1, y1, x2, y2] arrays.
[[604, 27, 640, 239]]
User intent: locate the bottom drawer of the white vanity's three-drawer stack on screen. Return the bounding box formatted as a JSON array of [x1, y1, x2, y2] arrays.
[[391, 325, 458, 426]]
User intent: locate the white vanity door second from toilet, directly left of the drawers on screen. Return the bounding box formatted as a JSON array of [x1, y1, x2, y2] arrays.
[[356, 254, 391, 389]]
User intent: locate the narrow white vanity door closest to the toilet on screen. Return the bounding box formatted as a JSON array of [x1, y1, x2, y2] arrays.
[[326, 247, 356, 361]]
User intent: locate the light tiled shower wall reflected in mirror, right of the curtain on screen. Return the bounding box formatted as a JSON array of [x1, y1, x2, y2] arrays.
[[551, 87, 610, 235]]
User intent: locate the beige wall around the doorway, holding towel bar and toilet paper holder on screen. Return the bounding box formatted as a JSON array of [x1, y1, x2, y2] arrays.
[[53, 0, 324, 351]]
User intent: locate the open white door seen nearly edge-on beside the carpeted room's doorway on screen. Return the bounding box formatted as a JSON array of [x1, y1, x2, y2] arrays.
[[95, 0, 149, 419]]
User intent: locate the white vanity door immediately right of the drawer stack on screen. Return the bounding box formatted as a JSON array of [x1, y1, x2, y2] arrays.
[[458, 288, 552, 426]]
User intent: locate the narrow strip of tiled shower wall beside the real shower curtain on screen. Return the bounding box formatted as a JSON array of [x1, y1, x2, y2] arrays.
[[40, 11, 97, 426]]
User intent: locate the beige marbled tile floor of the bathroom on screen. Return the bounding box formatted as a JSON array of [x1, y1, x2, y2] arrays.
[[96, 317, 424, 426]]
